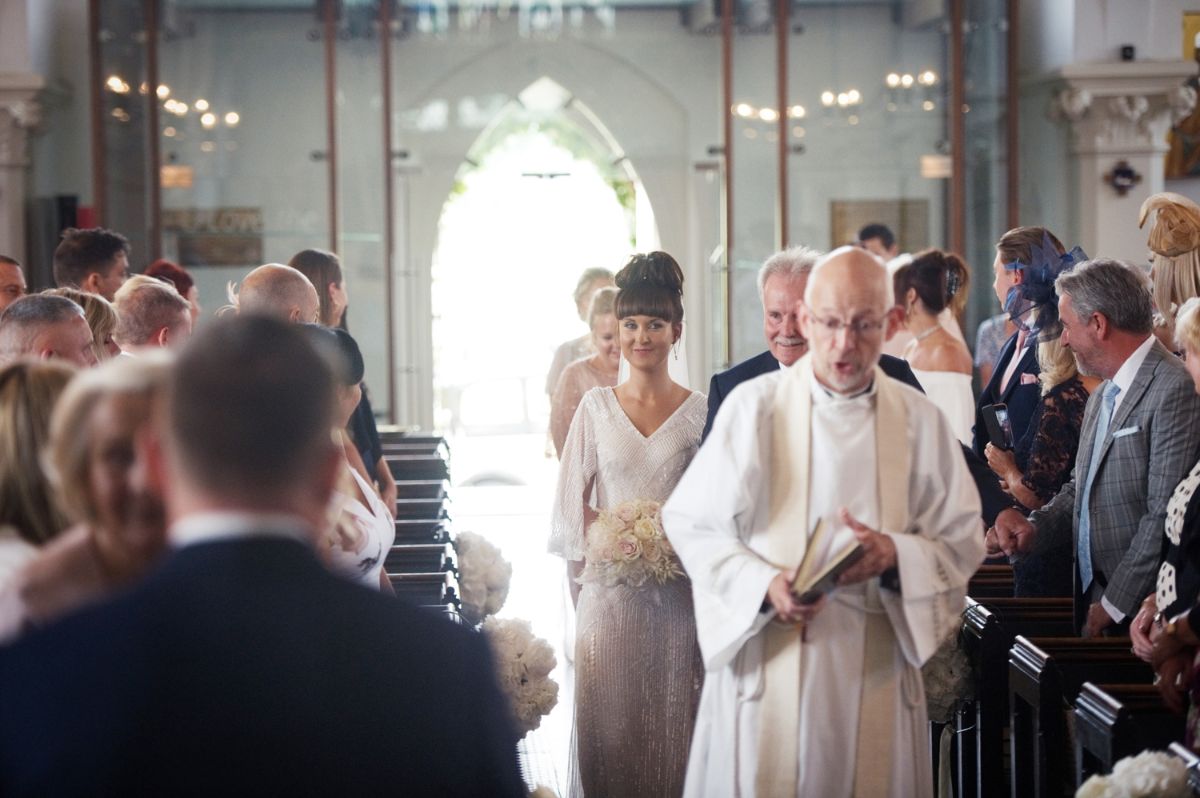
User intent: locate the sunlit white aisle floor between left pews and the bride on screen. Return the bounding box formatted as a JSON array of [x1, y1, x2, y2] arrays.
[[450, 436, 574, 798]]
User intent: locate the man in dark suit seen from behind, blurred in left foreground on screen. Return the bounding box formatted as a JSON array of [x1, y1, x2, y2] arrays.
[[0, 316, 524, 796]]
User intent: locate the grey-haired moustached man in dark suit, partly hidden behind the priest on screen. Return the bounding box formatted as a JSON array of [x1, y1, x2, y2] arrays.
[[701, 246, 1013, 526]]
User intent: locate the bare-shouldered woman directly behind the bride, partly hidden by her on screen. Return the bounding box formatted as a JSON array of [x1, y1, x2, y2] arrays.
[[550, 287, 620, 457]]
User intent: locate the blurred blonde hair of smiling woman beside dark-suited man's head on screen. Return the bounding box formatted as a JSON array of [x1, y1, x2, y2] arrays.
[[46, 349, 173, 522]]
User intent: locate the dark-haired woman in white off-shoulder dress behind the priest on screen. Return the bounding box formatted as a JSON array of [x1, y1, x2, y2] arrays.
[[892, 250, 974, 445]]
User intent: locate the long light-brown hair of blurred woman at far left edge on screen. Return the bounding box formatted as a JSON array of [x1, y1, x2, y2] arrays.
[[0, 360, 76, 546]]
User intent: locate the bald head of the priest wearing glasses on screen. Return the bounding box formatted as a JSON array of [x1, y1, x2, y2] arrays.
[[800, 246, 900, 394]]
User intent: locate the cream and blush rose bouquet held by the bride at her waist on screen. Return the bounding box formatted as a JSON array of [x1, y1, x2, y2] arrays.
[[580, 499, 684, 587]]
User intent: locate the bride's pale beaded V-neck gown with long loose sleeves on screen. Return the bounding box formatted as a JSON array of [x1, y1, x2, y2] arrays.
[[550, 388, 707, 798]]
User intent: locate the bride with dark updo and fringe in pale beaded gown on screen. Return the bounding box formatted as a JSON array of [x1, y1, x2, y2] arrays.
[[550, 252, 707, 798]]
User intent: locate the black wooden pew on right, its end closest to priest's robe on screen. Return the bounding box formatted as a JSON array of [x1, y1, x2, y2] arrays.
[[953, 598, 1074, 798]]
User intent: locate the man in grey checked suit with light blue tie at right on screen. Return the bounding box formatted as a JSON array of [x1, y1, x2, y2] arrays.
[[988, 259, 1200, 637]]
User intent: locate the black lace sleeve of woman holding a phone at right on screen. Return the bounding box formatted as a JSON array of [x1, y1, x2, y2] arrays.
[[1021, 377, 1087, 502]]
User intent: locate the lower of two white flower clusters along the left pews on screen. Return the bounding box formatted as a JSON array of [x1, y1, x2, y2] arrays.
[[481, 617, 558, 738]]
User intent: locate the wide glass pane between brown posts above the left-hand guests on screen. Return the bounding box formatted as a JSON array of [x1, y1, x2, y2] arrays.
[[156, 0, 330, 321]]
